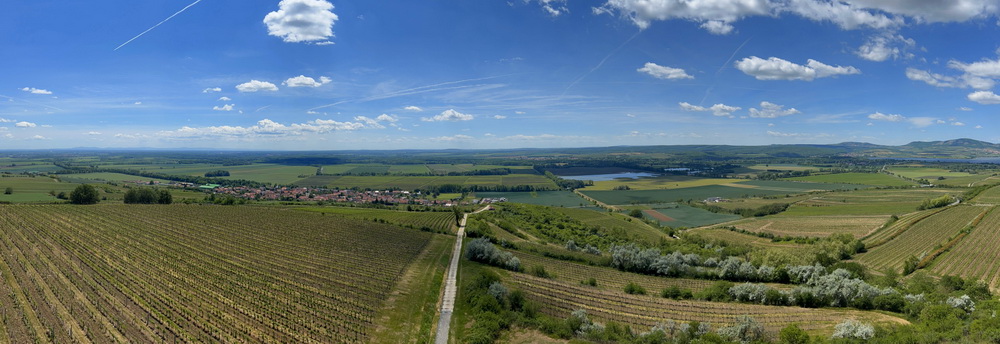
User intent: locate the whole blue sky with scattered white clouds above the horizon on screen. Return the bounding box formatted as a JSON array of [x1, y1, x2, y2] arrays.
[[0, 0, 1000, 150]]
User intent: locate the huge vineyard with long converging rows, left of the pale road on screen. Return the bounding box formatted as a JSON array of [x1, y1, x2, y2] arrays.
[[0, 205, 431, 343]]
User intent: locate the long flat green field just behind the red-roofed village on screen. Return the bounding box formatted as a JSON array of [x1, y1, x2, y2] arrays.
[[295, 174, 557, 190]]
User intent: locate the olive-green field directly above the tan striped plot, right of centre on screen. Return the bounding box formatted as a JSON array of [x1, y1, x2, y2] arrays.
[[781, 188, 962, 216]]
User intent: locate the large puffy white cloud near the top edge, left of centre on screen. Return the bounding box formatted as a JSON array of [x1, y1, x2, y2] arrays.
[[264, 0, 338, 45]]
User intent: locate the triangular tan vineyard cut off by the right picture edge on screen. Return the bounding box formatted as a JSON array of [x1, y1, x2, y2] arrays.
[[931, 210, 1000, 290]]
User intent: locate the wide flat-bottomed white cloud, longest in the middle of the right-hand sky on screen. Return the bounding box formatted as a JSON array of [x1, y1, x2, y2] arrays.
[[736, 56, 861, 81]]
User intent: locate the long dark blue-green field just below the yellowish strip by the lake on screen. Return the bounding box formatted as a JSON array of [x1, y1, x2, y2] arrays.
[[581, 181, 859, 205]]
